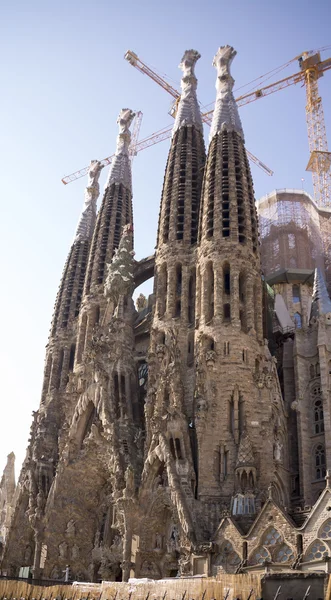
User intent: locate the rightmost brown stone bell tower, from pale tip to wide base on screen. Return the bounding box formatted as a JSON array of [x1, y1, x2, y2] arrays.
[[195, 46, 287, 516]]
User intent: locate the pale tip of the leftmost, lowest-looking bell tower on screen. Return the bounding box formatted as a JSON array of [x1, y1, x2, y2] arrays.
[[74, 160, 103, 243]]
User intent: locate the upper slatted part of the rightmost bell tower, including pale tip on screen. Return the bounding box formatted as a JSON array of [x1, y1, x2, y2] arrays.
[[199, 46, 258, 253]]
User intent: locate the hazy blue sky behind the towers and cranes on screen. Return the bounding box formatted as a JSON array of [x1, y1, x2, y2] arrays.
[[0, 0, 331, 476]]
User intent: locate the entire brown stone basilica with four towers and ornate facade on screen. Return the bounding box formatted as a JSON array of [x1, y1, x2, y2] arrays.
[[0, 46, 331, 581]]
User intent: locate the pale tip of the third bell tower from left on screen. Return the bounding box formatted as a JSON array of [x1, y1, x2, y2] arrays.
[[172, 50, 203, 134]]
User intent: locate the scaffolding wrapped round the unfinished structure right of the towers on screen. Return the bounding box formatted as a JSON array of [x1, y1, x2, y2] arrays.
[[257, 188, 331, 284]]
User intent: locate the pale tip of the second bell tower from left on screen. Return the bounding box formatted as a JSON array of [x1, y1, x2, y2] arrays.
[[106, 108, 135, 190]]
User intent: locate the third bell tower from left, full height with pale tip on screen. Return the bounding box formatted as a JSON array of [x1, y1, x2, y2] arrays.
[[137, 50, 205, 576]]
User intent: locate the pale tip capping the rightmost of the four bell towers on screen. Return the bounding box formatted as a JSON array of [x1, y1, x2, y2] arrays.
[[209, 46, 244, 140]]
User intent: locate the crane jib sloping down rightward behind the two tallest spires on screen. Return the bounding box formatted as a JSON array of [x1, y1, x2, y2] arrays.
[[124, 50, 274, 176]]
